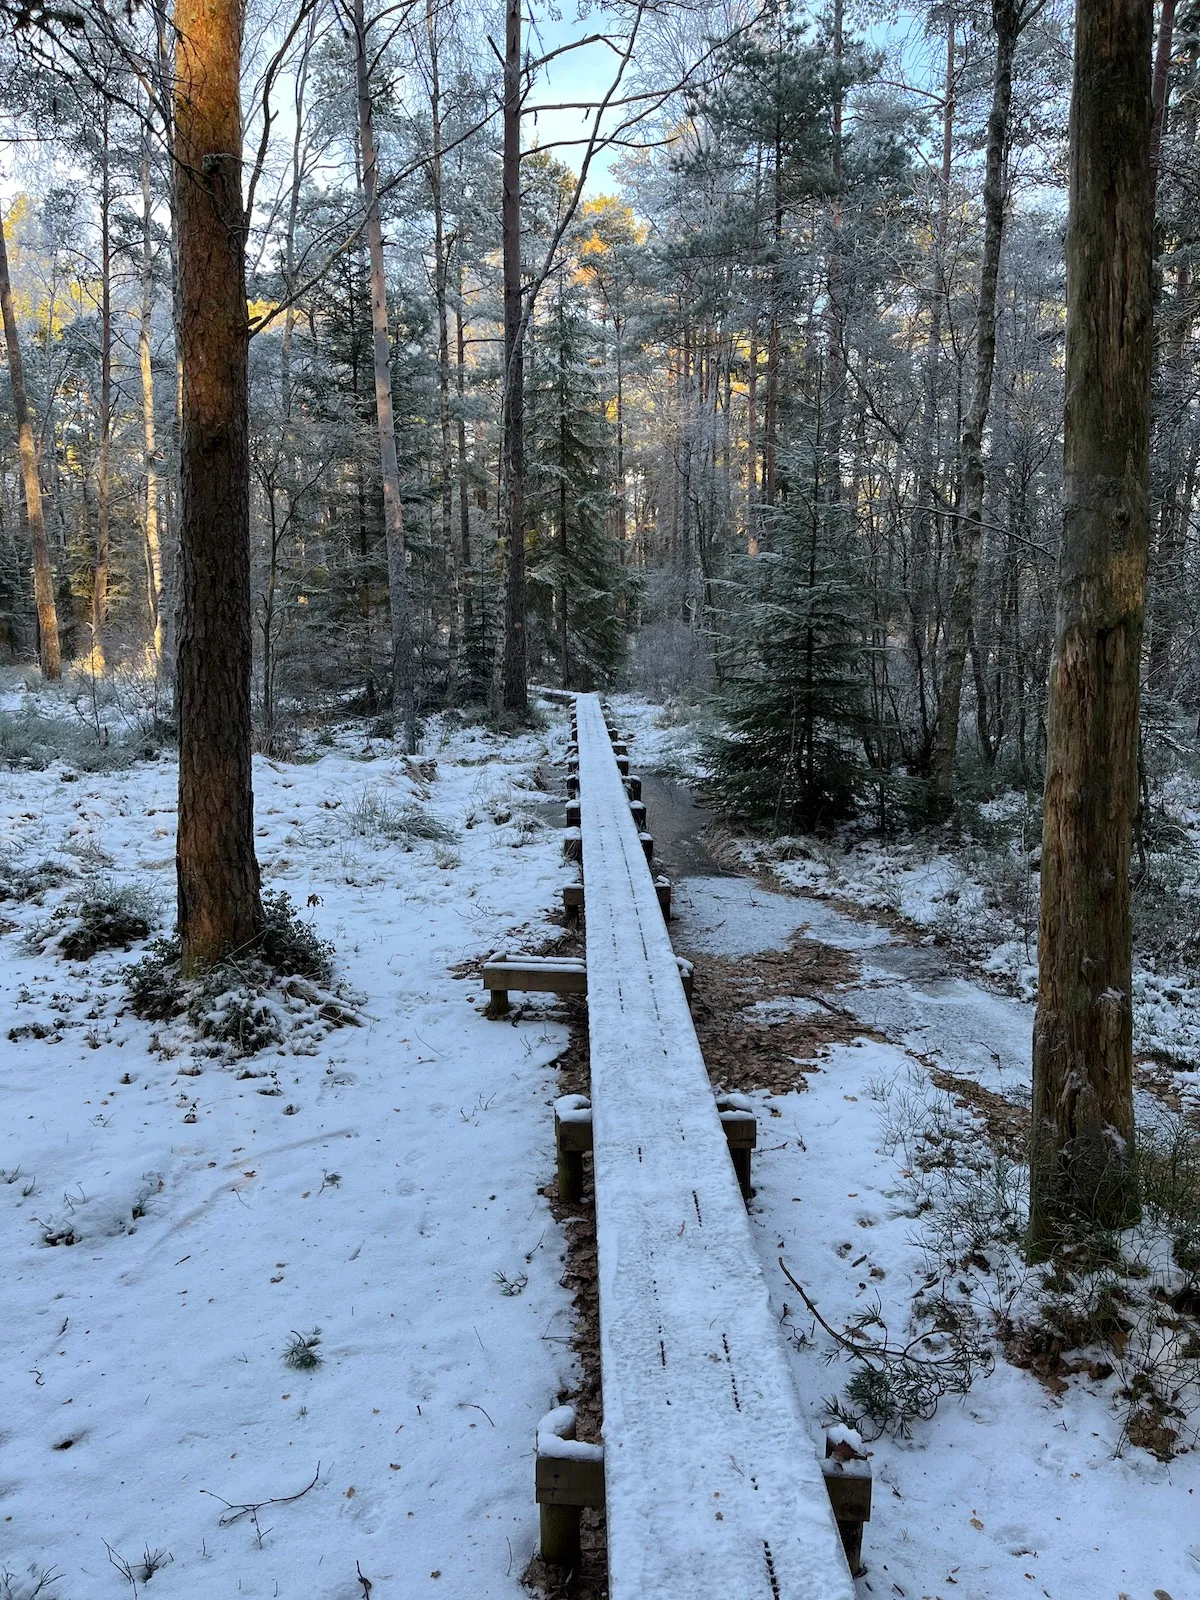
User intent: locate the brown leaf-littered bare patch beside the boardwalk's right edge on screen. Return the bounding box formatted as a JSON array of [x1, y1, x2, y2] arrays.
[[685, 934, 870, 1094]]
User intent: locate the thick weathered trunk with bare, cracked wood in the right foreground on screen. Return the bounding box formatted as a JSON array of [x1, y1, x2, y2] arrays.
[[1029, 0, 1154, 1259]]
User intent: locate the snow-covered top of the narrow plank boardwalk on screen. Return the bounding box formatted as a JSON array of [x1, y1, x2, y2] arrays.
[[576, 694, 854, 1600]]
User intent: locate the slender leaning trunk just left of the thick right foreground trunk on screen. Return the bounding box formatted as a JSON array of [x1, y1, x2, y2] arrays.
[[933, 0, 1029, 810]]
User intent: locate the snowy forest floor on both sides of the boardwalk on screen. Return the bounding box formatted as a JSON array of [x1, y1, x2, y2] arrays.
[[0, 688, 1200, 1600]]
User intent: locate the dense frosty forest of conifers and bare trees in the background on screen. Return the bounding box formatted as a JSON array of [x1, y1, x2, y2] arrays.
[[0, 0, 1200, 822]]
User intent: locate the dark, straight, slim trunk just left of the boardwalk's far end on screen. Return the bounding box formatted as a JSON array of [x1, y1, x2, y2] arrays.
[[501, 0, 530, 715]]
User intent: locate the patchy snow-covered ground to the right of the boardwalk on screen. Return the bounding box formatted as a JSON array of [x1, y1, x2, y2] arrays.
[[672, 876, 1200, 1600]]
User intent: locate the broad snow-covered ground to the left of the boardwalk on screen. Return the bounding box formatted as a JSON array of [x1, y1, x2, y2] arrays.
[[0, 700, 573, 1600]]
